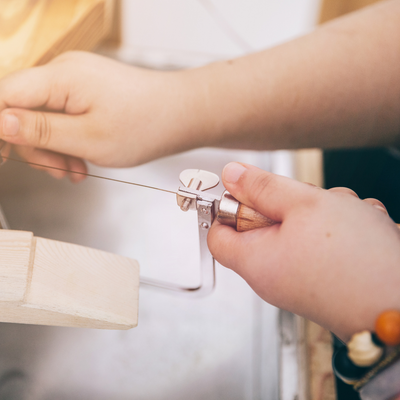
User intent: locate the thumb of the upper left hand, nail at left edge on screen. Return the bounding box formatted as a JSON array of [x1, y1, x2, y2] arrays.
[[0, 108, 87, 158]]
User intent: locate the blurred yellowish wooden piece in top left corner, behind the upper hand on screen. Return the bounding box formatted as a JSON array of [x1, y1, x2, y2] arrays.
[[0, 0, 113, 78]]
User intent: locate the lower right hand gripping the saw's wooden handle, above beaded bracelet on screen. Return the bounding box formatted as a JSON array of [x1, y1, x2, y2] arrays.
[[208, 163, 400, 340]]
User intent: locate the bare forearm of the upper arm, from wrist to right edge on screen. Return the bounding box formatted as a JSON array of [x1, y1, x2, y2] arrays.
[[185, 1, 400, 149]]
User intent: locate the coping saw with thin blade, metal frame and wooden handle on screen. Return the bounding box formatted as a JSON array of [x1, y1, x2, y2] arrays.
[[0, 150, 275, 297]]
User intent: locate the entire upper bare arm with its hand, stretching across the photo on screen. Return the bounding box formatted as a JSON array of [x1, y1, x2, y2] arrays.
[[0, 0, 400, 168]]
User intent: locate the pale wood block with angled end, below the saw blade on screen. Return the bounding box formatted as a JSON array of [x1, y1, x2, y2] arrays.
[[0, 230, 139, 329]]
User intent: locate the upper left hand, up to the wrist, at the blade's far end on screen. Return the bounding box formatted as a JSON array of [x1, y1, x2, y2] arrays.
[[0, 52, 200, 179]]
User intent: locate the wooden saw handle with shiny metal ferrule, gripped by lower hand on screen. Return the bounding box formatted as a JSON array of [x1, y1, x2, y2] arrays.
[[217, 190, 276, 232]]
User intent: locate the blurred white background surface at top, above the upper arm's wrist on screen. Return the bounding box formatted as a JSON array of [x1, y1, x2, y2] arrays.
[[121, 0, 319, 67]]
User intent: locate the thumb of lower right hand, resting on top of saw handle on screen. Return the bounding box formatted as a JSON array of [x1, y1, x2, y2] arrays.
[[222, 162, 315, 222]]
